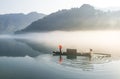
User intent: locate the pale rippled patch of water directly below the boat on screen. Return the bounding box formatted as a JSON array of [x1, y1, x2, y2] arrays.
[[42, 54, 113, 71]]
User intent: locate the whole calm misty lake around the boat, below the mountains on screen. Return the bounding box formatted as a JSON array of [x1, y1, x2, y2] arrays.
[[0, 31, 120, 79]]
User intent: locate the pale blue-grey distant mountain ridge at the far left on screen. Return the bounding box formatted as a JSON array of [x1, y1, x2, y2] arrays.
[[0, 12, 45, 34]]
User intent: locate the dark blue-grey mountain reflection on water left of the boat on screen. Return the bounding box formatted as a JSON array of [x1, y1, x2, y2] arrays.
[[0, 38, 53, 57]]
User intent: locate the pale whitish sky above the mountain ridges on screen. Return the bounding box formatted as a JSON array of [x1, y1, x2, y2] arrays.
[[0, 0, 120, 14]]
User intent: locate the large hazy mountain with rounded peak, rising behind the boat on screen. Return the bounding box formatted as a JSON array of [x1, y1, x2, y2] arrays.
[[17, 4, 120, 32]]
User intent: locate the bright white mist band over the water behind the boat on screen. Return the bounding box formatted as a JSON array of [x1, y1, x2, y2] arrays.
[[10, 31, 120, 55]]
